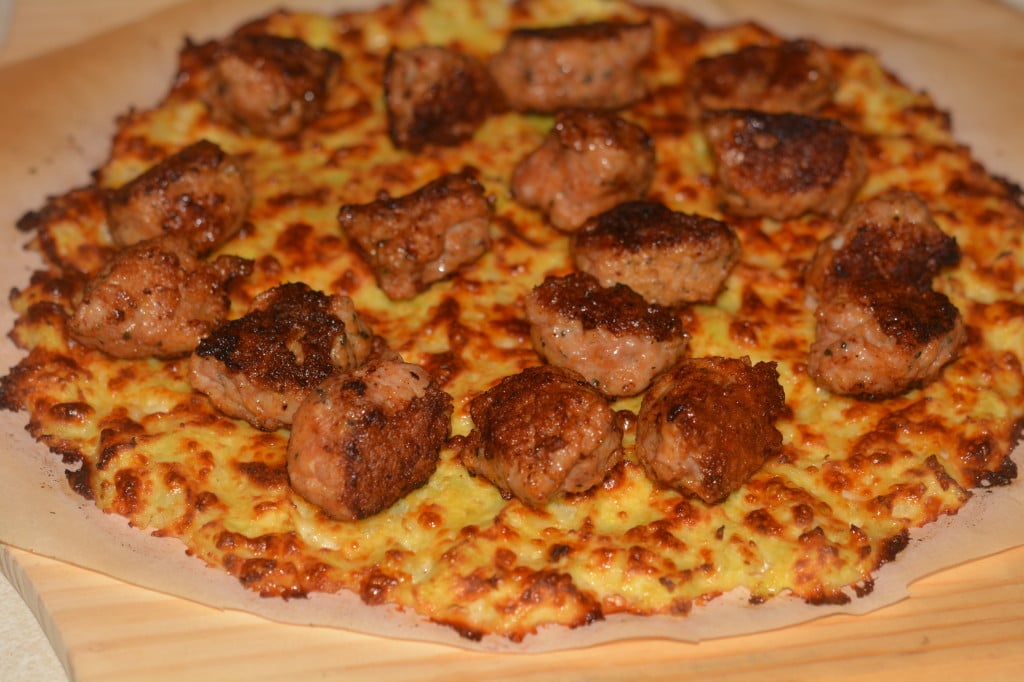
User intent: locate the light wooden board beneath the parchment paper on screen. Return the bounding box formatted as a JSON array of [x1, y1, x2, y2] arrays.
[[0, 0, 1024, 682]]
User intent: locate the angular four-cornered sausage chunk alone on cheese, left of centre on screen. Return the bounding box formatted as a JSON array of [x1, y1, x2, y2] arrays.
[[338, 171, 494, 300]]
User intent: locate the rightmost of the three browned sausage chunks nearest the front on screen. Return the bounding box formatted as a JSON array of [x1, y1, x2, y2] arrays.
[[636, 357, 785, 504]]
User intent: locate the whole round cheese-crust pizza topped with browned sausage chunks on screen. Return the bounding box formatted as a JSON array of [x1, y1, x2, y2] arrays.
[[0, 0, 1024, 642]]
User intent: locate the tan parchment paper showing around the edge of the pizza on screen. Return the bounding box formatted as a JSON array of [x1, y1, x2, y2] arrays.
[[0, 0, 1024, 651]]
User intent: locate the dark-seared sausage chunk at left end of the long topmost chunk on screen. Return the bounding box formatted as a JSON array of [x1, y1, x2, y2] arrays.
[[384, 45, 502, 152]]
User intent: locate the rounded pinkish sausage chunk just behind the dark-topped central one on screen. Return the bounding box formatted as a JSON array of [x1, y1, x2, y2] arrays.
[[511, 111, 655, 231]]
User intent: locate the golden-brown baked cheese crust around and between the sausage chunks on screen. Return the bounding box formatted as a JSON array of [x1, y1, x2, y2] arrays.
[[0, 0, 1024, 640]]
